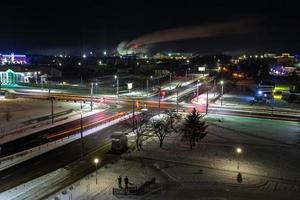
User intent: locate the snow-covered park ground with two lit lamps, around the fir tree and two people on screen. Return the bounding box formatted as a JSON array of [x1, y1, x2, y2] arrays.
[[2, 112, 300, 200]]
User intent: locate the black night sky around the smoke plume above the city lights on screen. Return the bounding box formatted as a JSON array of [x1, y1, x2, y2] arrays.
[[0, 0, 300, 54]]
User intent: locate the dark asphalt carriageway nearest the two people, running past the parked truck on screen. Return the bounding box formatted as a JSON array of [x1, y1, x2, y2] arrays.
[[0, 122, 126, 192]]
